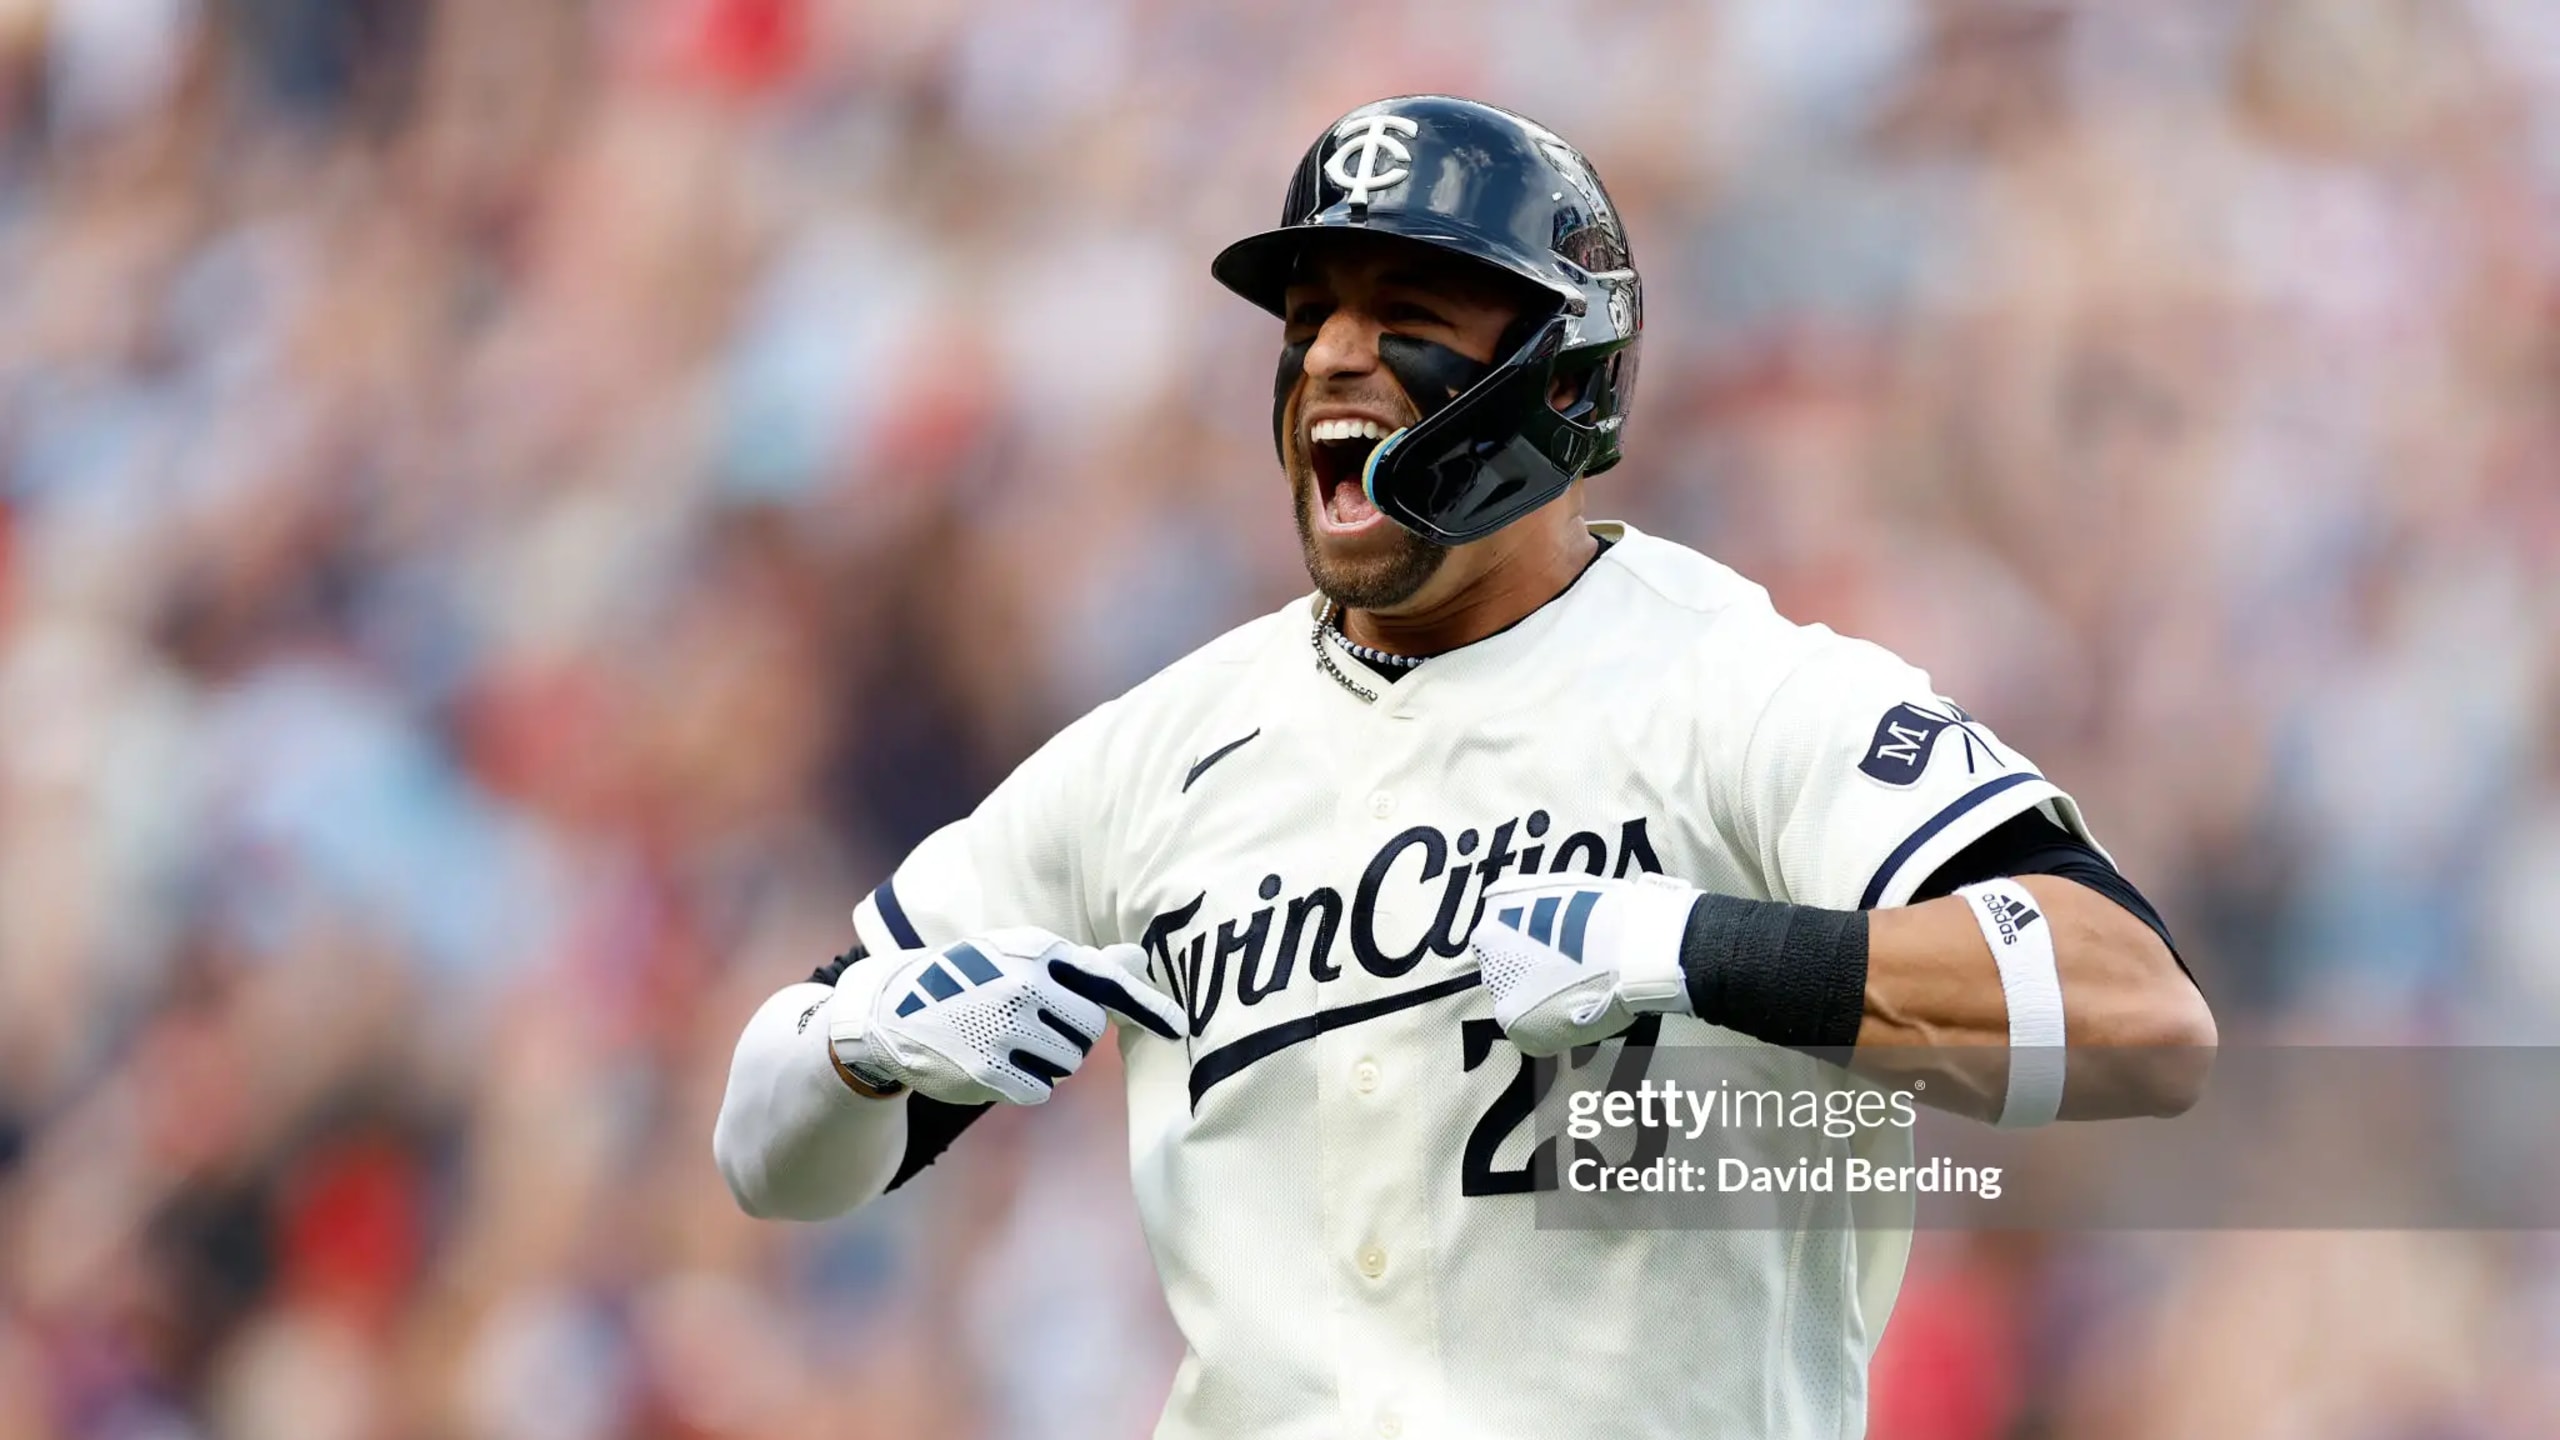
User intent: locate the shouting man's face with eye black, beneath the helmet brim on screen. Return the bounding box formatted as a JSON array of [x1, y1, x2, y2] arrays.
[[1280, 236, 1521, 610]]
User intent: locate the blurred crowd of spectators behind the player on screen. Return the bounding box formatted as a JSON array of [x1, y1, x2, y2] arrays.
[[0, 0, 2560, 1440]]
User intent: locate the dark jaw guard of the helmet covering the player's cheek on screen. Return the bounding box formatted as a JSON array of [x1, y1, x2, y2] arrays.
[[1362, 315, 1597, 546]]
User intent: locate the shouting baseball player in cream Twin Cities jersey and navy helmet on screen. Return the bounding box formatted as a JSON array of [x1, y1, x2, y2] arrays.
[[714, 95, 2214, 1440]]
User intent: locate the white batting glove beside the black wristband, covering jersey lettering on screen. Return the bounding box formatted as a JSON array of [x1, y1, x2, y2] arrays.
[[1472, 874, 1700, 1056]]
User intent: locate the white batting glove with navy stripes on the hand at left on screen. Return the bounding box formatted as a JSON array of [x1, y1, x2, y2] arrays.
[[827, 928, 1188, 1104]]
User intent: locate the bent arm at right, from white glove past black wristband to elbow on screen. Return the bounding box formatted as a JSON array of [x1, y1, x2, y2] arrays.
[[1475, 871, 2214, 1125]]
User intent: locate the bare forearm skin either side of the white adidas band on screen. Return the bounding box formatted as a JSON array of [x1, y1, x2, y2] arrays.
[[1859, 876, 2217, 1120]]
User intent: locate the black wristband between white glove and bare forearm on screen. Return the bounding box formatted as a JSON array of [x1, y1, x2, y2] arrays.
[[1679, 894, 1866, 1051]]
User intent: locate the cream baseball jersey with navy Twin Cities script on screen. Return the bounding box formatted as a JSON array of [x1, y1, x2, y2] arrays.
[[855, 525, 2084, 1440]]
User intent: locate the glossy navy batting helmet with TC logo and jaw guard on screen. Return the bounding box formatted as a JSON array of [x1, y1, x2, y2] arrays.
[[1208, 95, 1644, 546]]
